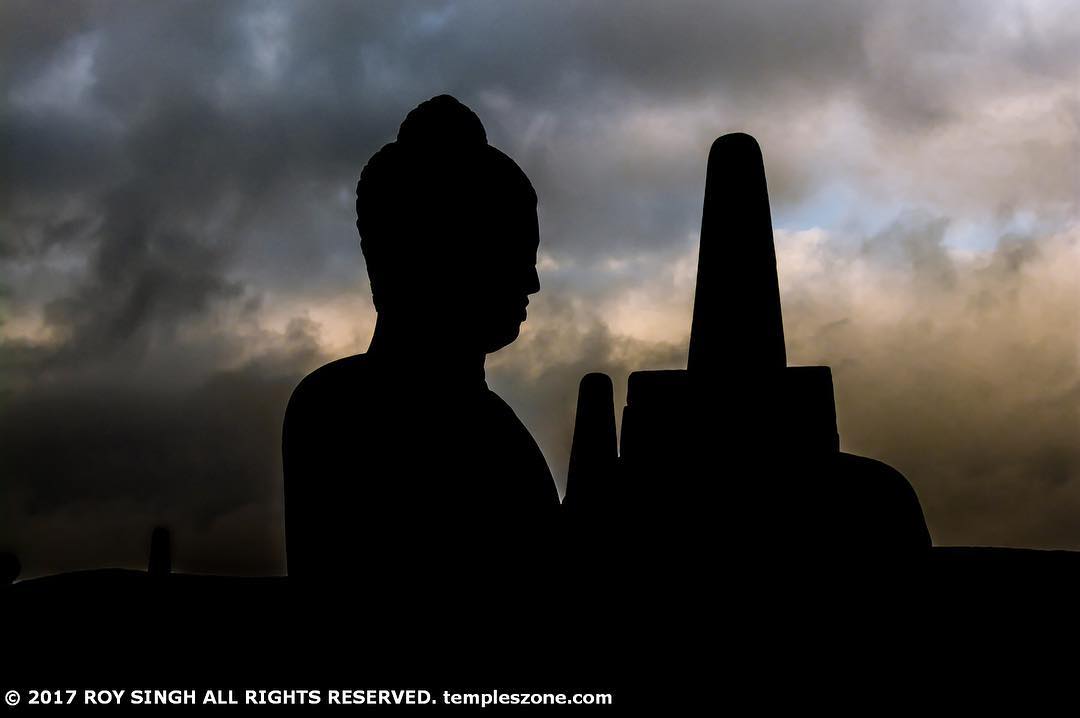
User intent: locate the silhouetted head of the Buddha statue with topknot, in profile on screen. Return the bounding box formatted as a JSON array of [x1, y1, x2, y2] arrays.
[[356, 95, 540, 353]]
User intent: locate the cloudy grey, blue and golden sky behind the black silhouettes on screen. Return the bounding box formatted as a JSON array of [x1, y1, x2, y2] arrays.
[[0, 0, 1080, 574]]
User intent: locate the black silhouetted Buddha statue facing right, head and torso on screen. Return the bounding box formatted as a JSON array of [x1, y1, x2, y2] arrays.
[[283, 95, 558, 581]]
